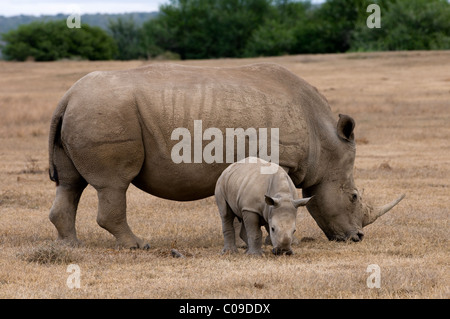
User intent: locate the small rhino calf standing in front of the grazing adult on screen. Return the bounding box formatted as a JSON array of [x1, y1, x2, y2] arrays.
[[215, 157, 311, 255]]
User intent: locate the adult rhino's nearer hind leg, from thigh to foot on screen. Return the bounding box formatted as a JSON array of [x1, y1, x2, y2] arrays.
[[63, 132, 149, 249]]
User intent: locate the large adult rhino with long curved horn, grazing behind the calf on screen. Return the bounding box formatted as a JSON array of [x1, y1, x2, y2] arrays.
[[49, 63, 403, 248]]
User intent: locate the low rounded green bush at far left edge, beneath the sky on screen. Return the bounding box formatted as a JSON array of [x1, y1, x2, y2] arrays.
[[2, 21, 117, 61]]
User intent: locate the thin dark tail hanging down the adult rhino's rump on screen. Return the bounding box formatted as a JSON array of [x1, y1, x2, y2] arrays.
[[48, 96, 68, 186]]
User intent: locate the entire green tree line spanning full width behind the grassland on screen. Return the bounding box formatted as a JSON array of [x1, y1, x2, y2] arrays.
[[2, 0, 450, 61]]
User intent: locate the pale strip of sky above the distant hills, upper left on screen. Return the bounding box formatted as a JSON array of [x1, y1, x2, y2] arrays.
[[0, 0, 324, 17]]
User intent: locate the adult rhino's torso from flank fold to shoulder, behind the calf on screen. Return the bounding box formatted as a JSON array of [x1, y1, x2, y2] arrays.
[[128, 64, 326, 199]]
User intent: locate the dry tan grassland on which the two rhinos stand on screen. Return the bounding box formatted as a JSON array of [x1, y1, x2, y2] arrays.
[[0, 51, 450, 298]]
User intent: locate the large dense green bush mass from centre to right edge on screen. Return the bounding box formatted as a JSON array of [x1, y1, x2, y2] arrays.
[[144, 0, 450, 59]]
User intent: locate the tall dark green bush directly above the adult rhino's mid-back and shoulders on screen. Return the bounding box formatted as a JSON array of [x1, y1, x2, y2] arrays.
[[144, 0, 271, 59]]
